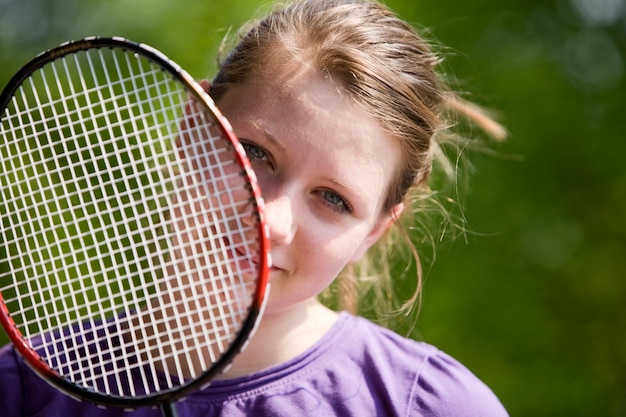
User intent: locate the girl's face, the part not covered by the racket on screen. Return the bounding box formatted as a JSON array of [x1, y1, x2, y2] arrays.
[[217, 68, 402, 315]]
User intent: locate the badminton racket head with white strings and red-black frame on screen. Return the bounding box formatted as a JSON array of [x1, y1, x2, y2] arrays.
[[0, 37, 271, 408]]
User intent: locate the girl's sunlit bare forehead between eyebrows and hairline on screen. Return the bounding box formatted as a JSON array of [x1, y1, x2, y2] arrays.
[[218, 67, 400, 211]]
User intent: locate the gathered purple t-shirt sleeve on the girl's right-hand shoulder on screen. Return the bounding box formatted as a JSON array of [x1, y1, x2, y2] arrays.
[[412, 351, 508, 417]]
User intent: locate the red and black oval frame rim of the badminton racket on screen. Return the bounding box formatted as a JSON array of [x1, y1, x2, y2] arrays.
[[0, 36, 271, 414]]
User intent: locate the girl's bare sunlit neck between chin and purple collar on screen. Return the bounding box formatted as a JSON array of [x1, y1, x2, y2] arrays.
[[216, 300, 338, 379]]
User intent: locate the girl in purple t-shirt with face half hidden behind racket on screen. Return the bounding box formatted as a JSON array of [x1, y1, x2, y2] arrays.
[[0, 0, 507, 417]]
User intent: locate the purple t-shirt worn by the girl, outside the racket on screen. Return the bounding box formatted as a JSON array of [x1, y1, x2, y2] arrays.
[[0, 313, 508, 417]]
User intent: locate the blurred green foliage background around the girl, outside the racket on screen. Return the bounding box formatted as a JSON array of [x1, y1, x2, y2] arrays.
[[0, 0, 626, 417]]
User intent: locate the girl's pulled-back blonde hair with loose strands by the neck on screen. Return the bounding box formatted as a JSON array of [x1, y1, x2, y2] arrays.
[[211, 0, 504, 326]]
